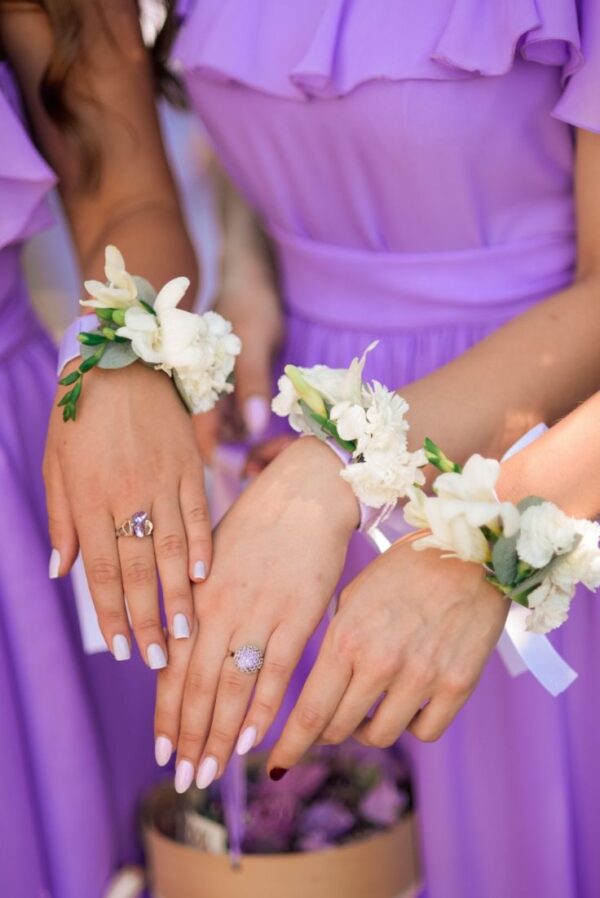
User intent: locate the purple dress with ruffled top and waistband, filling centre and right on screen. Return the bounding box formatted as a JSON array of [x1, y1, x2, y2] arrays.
[[176, 0, 600, 898]]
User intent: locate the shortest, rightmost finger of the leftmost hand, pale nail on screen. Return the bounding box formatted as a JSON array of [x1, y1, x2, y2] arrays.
[[179, 463, 212, 583]]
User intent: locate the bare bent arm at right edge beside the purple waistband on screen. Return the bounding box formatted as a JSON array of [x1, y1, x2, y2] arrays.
[[401, 131, 600, 461]]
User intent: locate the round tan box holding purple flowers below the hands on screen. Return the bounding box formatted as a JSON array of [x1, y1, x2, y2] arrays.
[[143, 783, 419, 898]]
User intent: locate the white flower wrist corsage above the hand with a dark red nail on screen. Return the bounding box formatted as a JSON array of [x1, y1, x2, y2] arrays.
[[404, 440, 600, 633]]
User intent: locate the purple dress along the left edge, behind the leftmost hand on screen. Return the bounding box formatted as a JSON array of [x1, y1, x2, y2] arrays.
[[0, 64, 162, 898]]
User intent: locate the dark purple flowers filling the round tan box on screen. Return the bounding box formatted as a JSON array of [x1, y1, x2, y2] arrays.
[[180, 741, 412, 854]]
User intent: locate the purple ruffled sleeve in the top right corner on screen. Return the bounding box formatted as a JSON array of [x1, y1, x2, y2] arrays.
[[553, 0, 600, 133]]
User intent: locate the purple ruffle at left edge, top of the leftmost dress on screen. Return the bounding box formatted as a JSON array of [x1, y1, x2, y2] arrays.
[[0, 64, 56, 249]]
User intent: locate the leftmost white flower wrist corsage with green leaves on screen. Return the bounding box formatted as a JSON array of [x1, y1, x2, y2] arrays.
[[59, 246, 241, 421]]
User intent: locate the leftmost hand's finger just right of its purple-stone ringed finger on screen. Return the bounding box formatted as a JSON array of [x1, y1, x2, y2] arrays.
[[152, 495, 193, 639]]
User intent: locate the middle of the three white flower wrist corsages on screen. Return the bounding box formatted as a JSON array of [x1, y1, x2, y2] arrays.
[[272, 343, 427, 526]]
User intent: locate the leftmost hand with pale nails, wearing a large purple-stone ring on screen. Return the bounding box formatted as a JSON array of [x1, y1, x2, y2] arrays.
[[44, 363, 211, 668]]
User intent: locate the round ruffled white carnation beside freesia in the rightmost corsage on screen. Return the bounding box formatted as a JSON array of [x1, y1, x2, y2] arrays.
[[517, 502, 577, 569]]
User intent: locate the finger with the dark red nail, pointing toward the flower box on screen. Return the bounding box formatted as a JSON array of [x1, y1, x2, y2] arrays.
[[267, 649, 352, 779]]
